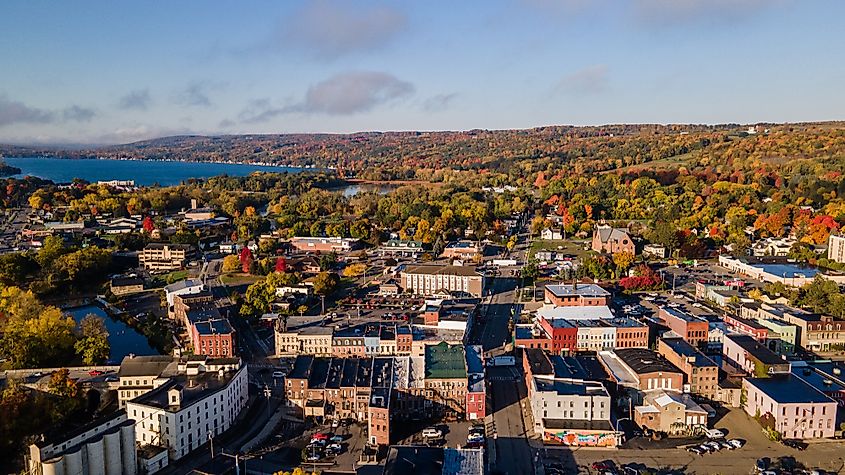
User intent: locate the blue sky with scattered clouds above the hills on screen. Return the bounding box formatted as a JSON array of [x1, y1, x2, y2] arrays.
[[0, 0, 845, 143]]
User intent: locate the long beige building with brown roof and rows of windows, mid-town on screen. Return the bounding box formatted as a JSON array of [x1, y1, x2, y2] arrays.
[[400, 265, 485, 297]]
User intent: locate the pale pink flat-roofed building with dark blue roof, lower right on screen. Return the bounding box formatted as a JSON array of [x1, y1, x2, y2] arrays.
[[742, 375, 836, 439]]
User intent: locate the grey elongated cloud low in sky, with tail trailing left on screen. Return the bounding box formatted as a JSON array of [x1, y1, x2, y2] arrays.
[[238, 71, 414, 123]]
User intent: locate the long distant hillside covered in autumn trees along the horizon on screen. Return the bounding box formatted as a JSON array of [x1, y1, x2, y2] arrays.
[[0, 122, 845, 179]]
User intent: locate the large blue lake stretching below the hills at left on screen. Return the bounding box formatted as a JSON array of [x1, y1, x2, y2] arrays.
[[3, 157, 314, 186]]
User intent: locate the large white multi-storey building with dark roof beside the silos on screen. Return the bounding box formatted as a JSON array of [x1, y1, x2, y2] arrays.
[[126, 358, 248, 460]]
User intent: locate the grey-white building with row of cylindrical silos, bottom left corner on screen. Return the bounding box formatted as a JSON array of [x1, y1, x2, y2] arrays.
[[26, 411, 137, 475]]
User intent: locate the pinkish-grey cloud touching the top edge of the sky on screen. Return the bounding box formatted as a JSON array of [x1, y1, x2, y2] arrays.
[[276, 0, 408, 58]]
